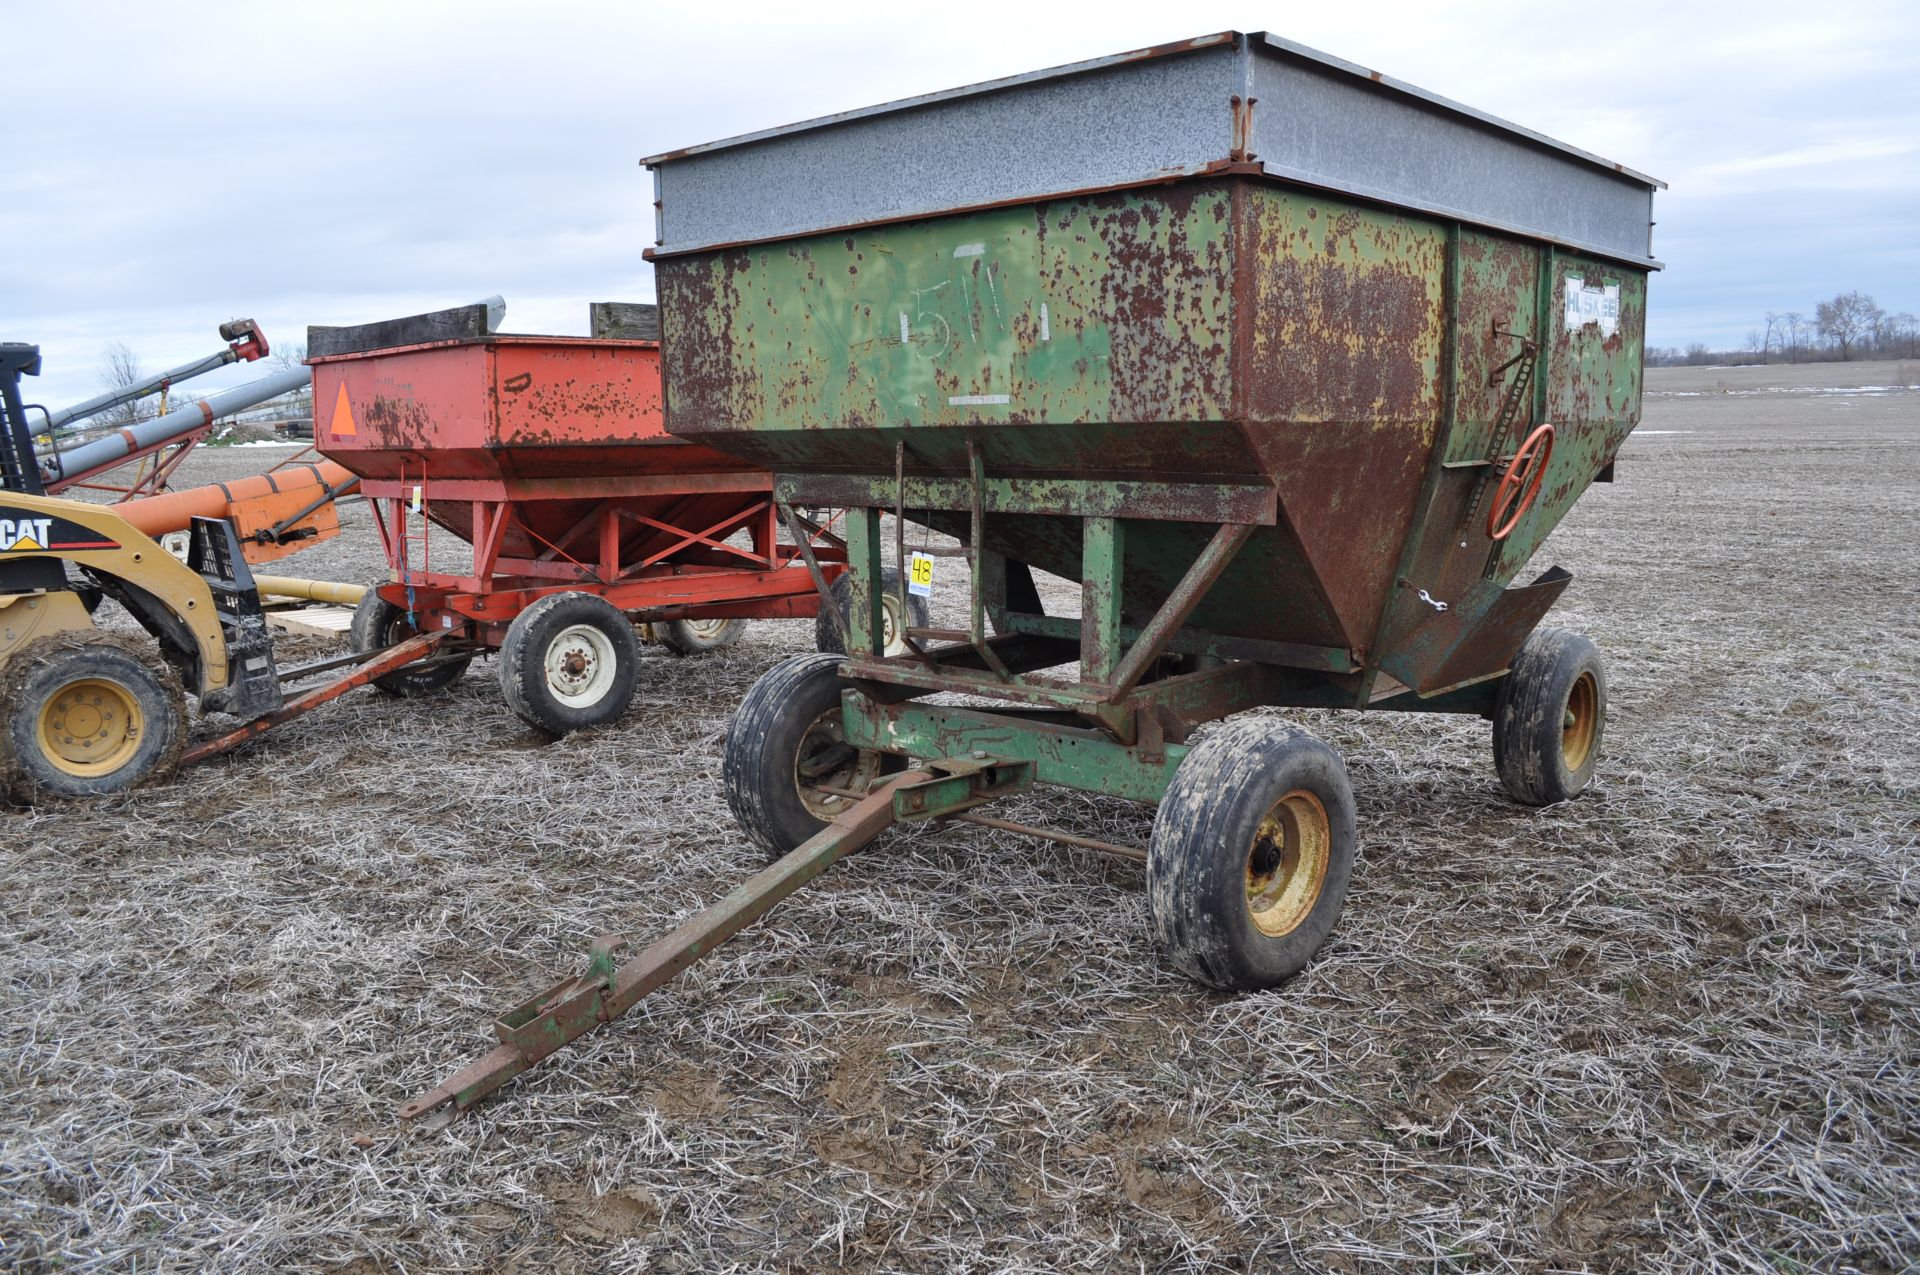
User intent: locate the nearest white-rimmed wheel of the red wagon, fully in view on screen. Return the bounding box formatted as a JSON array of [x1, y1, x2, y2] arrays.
[[499, 593, 639, 735]]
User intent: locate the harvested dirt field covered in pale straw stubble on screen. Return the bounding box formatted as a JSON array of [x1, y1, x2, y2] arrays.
[[0, 365, 1920, 1275]]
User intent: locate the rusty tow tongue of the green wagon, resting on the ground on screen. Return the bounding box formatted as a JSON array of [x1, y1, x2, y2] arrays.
[[399, 757, 1033, 1133]]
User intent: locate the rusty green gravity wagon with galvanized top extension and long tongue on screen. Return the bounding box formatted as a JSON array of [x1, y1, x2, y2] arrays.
[[409, 33, 1661, 1114]]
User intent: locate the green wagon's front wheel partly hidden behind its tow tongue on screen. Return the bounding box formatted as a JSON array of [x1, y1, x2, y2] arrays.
[[720, 655, 906, 858]]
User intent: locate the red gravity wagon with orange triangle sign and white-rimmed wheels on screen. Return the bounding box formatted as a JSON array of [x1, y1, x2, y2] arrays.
[[307, 303, 906, 734]]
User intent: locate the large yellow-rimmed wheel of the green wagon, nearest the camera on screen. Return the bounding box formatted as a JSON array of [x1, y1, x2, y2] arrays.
[[1146, 720, 1356, 991]]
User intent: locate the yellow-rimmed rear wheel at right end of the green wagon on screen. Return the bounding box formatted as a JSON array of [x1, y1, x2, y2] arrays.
[[1494, 628, 1607, 806]]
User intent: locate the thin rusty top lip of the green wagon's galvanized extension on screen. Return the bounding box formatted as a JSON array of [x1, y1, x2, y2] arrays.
[[639, 31, 1667, 190]]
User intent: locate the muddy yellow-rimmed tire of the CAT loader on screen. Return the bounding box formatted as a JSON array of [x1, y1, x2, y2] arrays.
[[0, 634, 186, 805]]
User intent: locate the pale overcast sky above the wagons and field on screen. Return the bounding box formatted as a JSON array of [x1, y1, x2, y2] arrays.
[[0, 0, 1920, 405]]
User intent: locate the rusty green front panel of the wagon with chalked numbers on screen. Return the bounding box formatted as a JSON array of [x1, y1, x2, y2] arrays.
[[659, 186, 1231, 455]]
